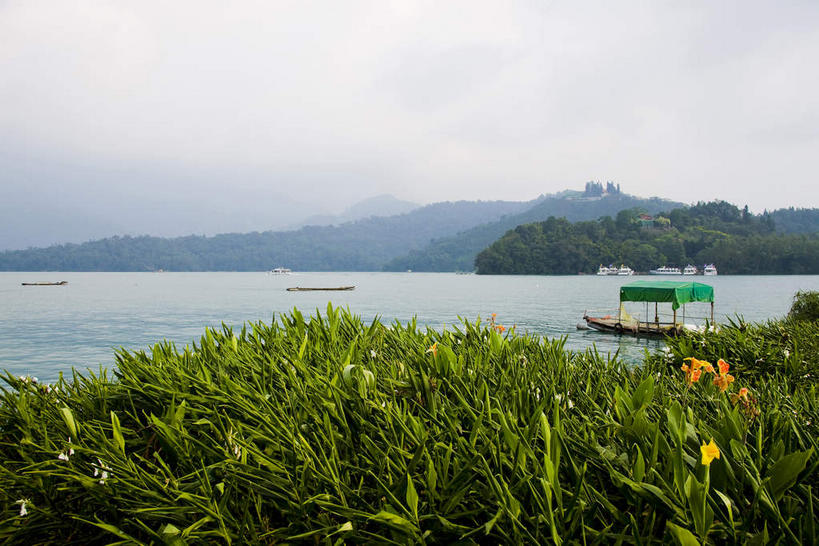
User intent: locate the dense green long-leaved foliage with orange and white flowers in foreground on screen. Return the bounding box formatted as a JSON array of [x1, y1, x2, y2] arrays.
[[0, 308, 819, 544]]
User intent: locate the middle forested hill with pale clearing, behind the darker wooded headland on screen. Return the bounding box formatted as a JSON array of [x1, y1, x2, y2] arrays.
[[384, 192, 682, 271]]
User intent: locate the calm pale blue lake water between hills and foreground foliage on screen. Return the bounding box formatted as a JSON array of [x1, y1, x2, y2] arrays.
[[0, 272, 819, 381]]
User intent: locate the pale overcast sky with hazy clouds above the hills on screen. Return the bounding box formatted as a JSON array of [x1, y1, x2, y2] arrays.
[[0, 0, 819, 248]]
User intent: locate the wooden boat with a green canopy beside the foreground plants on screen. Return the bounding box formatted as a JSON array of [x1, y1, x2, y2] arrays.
[[583, 281, 714, 336]]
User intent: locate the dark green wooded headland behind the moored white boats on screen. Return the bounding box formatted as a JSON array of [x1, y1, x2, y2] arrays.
[[475, 201, 819, 275]]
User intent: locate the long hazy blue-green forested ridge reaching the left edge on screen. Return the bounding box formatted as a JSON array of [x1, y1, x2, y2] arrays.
[[0, 201, 535, 271]]
